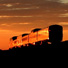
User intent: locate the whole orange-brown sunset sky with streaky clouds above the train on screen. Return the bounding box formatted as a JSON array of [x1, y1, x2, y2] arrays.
[[0, 0, 68, 50]]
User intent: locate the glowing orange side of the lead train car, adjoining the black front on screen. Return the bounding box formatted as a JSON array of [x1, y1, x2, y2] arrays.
[[29, 28, 49, 45]]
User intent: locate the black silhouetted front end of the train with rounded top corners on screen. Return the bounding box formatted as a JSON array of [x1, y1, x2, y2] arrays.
[[49, 25, 63, 43]]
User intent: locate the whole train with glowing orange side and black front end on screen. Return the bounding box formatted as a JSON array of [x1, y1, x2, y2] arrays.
[[10, 25, 63, 48]]
